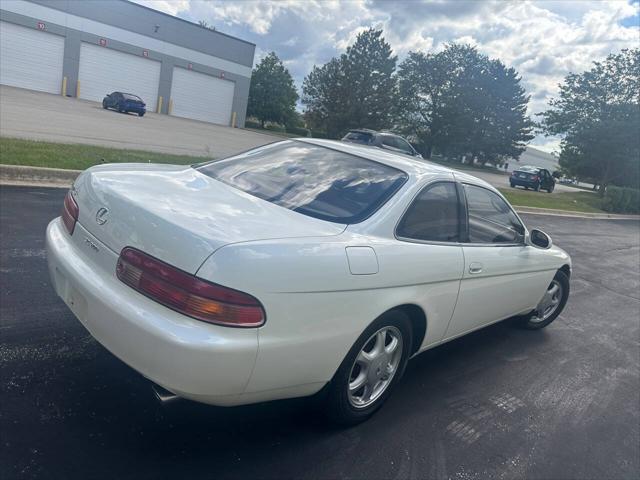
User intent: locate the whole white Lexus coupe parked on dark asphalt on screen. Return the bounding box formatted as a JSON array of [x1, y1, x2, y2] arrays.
[[46, 139, 571, 424]]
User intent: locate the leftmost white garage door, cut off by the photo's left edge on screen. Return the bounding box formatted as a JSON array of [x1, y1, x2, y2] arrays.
[[0, 22, 64, 93]]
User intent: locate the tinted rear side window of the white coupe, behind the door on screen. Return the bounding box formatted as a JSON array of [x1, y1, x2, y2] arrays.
[[396, 182, 460, 242]]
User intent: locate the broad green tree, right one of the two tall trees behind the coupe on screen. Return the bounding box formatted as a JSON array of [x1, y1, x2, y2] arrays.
[[397, 44, 533, 164]]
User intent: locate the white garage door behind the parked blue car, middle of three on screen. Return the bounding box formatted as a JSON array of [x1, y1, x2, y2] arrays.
[[78, 43, 160, 110]]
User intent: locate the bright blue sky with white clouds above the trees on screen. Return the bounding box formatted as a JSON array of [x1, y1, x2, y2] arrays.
[[135, 0, 640, 152]]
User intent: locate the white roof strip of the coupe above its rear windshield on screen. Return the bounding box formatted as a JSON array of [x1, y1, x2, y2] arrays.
[[295, 138, 495, 190]]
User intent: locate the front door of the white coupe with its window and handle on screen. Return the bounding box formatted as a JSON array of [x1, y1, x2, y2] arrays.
[[446, 183, 552, 338]]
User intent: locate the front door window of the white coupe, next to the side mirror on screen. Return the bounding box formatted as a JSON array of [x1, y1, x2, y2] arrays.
[[464, 185, 524, 243]]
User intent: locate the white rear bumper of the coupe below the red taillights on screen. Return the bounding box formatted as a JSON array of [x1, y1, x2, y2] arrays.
[[46, 218, 258, 405]]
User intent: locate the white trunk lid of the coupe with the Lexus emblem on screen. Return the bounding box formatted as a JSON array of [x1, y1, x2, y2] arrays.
[[74, 164, 345, 273]]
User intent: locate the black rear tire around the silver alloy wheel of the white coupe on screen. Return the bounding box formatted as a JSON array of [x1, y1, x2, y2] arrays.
[[325, 310, 413, 425]]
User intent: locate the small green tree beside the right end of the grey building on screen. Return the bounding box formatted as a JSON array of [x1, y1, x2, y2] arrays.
[[247, 52, 298, 128]]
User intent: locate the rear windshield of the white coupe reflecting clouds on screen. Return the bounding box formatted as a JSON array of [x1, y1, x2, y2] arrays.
[[197, 141, 407, 223]]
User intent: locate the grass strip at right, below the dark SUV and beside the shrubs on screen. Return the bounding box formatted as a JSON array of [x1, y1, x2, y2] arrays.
[[500, 188, 606, 213]]
